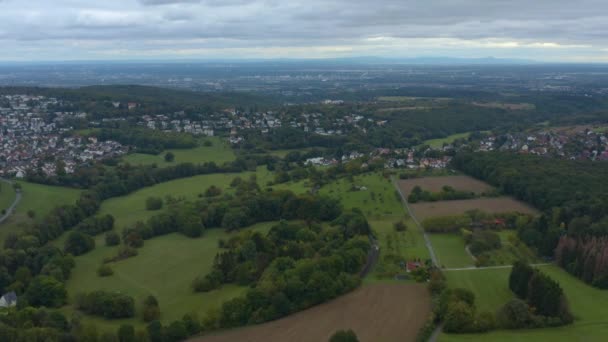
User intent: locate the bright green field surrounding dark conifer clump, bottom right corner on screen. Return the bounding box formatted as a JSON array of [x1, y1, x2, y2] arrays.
[[439, 265, 608, 342]]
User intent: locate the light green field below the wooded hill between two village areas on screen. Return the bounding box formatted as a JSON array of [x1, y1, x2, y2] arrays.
[[123, 137, 236, 167]]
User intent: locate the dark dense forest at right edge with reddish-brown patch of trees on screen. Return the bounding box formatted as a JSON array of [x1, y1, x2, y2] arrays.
[[453, 152, 608, 287]]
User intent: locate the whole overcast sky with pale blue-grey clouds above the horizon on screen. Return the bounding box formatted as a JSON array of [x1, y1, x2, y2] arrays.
[[0, 0, 608, 62]]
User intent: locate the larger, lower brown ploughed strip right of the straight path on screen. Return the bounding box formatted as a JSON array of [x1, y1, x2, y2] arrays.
[[409, 197, 538, 221]]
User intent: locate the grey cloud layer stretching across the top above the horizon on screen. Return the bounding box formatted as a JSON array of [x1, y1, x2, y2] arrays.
[[0, 0, 608, 60]]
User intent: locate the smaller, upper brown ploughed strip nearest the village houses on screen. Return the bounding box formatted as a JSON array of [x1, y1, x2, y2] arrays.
[[399, 175, 493, 197]]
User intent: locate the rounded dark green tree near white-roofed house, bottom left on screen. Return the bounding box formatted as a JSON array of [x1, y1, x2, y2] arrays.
[[25, 276, 67, 308]]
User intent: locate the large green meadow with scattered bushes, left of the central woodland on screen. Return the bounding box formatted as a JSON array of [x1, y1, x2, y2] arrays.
[[63, 222, 275, 329]]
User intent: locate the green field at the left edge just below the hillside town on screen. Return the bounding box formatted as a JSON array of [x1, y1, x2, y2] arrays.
[[0, 181, 80, 243]]
